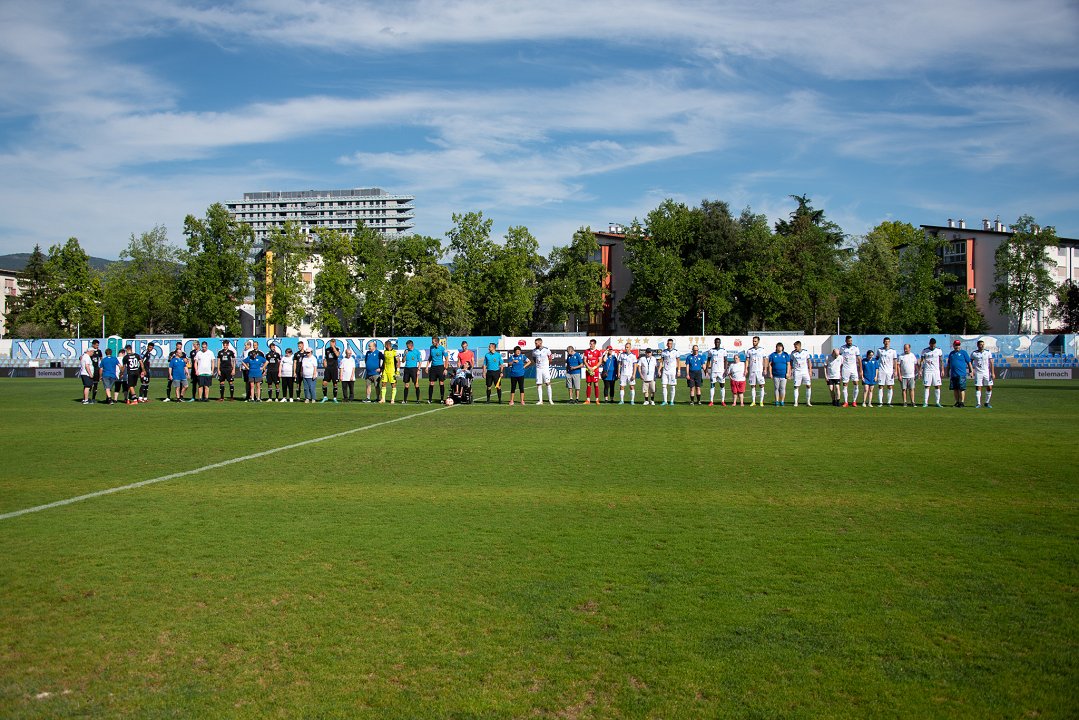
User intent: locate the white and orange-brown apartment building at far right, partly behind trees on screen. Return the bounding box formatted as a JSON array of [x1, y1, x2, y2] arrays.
[[921, 218, 1079, 334]]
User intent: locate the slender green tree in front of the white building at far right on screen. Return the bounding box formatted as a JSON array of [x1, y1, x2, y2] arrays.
[[989, 215, 1056, 332]]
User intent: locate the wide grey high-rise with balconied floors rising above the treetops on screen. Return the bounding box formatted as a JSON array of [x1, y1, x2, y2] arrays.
[[226, 188, 415, 245]]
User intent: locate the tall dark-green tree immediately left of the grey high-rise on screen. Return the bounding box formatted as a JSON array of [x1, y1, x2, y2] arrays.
[[179, 203, 255, 337]]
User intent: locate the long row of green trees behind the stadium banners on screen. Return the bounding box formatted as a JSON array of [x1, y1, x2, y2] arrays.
[[5, 195, 1079, 337]]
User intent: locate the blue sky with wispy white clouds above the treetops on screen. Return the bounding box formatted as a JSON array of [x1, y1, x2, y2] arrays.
[[0, 0, 1079, 258]]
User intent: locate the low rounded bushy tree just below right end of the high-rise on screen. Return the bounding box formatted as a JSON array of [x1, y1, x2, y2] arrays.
[[397, 264, 473, 337]]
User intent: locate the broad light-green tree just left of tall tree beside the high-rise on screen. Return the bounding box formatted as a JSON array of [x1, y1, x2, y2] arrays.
[[101, 226, 180, 337]]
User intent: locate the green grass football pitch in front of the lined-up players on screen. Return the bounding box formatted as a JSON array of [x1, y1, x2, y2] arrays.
[[0, 379, 1079, 719]]
